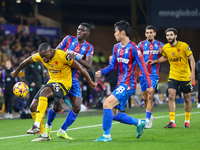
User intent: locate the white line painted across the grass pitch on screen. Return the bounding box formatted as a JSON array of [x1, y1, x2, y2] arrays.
[[0, 112, 200, 140]]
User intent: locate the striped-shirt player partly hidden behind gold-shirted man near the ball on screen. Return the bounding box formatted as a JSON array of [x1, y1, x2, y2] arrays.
[[46, 23, 94, 139]]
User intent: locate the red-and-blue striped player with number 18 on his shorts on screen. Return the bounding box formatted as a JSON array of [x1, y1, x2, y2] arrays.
[[95, 20, 153, 142]]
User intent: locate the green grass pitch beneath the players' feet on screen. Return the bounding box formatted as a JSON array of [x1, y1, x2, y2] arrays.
[[0, 104, 200, 150]]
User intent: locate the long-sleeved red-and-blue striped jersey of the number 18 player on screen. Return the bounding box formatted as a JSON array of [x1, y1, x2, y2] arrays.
[[101, 41, 151, 89]]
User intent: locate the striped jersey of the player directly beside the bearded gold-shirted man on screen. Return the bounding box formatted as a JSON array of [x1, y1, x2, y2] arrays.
[[138, 40, 164, 75]]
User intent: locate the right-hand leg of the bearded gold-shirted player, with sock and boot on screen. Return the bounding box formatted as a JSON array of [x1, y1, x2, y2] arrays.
[[183, 93, 192, 128]]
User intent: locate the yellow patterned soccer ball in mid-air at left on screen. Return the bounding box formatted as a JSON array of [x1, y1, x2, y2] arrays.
[[13, 82, 29, 98]]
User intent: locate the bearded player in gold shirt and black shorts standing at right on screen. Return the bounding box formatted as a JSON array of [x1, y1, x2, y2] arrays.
[[147, 28, 195, 128]]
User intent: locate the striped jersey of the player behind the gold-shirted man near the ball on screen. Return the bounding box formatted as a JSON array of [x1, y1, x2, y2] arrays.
[[59, 35, 94, 79]]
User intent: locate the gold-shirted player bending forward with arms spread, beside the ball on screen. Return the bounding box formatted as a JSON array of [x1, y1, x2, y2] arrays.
[[11, 43, 96, 141]]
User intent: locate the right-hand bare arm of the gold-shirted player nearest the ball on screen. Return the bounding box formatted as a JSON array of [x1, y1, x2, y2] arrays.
[[71, 60, 97, 89]]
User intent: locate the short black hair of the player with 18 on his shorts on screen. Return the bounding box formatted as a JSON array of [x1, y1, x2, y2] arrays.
[[114, 20, 131, 37]]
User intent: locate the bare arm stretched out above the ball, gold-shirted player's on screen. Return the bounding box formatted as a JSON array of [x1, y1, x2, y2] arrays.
[[11, 56, 34, 78]]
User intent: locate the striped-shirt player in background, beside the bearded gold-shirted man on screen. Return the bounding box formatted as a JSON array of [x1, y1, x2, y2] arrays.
[[138, 25, 164, 128]]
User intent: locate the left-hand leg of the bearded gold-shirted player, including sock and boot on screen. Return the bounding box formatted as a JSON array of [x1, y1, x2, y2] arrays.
[[164, 88, 176, 128]]
